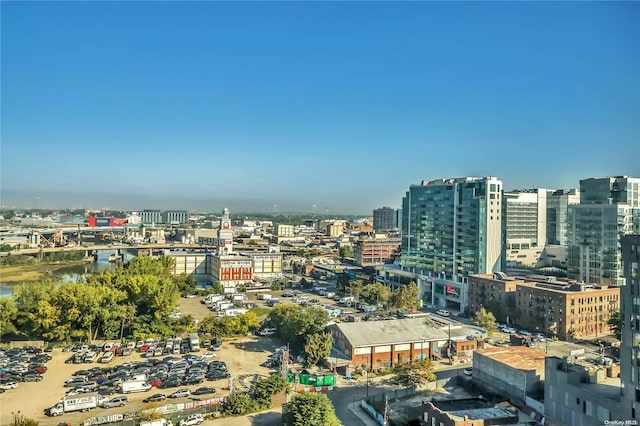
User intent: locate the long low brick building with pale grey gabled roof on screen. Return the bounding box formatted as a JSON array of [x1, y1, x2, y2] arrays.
[[328, 315, 483, 369]]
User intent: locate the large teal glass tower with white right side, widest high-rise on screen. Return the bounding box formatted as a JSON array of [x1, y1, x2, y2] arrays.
[[401, 177, 502, 280]]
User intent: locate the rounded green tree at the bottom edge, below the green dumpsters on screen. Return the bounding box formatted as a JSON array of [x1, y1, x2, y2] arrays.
[[285, 392, 340, 426]]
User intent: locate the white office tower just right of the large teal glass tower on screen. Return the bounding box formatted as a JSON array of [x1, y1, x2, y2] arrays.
[[503, 188, 550, 266]]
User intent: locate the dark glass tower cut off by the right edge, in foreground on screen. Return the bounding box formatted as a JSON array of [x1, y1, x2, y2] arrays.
[[620, 235, 640, 420]]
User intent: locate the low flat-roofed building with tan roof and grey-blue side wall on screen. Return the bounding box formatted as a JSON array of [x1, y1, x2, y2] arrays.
[[473, 346, 545, 401]]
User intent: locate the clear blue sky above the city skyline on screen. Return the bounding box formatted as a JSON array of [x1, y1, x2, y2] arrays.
[[1, 2, 640, 214]]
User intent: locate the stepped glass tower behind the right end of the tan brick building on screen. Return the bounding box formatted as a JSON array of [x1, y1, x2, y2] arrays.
[[567, 176, 640, 285]]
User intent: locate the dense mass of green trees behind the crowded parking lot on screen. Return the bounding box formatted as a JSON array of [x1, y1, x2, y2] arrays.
[[0, 257, 195, 342]]
